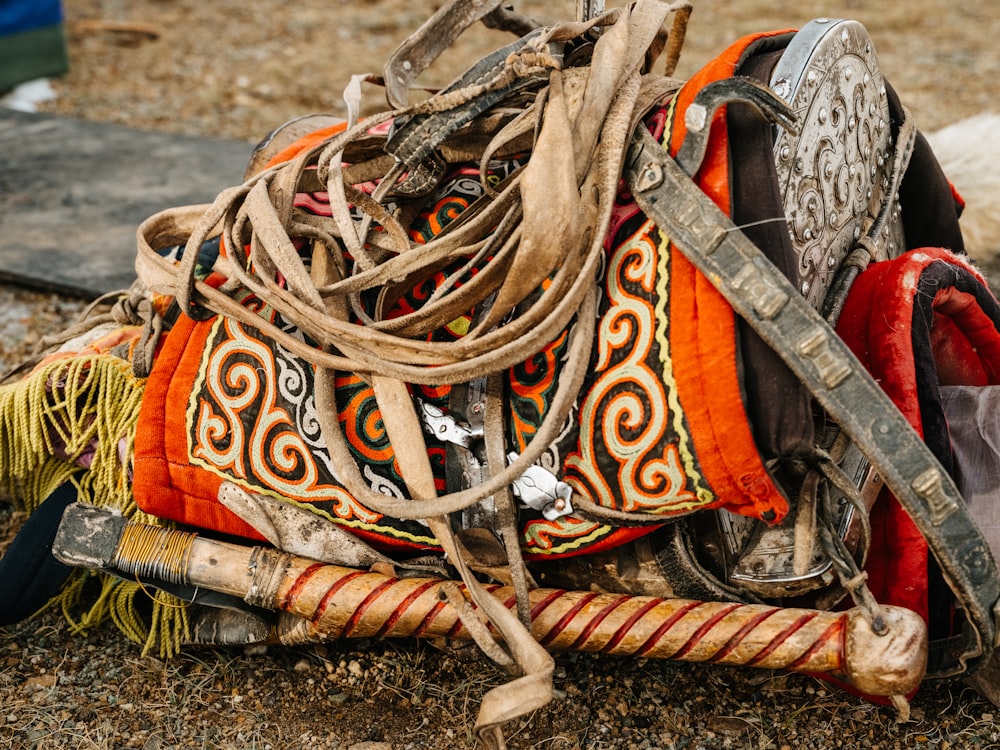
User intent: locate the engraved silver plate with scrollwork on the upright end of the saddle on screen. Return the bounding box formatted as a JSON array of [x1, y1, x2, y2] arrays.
[[771, 19, 903, 308]]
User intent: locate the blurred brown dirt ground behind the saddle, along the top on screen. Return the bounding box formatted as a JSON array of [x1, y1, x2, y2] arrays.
[[41, 0, 1000, 141]]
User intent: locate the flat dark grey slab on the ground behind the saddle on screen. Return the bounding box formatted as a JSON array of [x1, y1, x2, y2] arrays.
[[0, 107, 253, 297]]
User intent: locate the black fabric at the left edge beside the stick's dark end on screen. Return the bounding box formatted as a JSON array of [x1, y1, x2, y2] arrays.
[[0, 483, 77, 626]]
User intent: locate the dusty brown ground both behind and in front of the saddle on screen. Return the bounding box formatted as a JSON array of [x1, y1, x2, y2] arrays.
[[0, 0, 1000, 750]]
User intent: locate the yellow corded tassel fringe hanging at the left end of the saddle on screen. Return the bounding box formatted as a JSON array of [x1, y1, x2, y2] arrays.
[[0, 355, 190, 658]]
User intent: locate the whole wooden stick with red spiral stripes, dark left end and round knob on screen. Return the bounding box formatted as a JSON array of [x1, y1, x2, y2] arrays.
[[53, 505, 927, 696]]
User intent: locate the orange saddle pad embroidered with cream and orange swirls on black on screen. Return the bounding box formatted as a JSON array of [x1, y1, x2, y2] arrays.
[[134, 20, 960, 568]]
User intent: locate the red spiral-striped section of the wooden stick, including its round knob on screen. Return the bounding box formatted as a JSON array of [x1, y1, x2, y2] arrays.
[[260, 548, 927, 696]]
